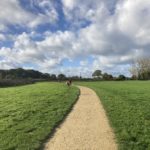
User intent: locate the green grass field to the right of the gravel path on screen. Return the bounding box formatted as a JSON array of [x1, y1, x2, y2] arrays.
[[78, 81, 150, 150]]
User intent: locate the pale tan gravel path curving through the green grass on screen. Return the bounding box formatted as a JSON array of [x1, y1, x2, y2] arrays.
[[45, 86, 117, 150]]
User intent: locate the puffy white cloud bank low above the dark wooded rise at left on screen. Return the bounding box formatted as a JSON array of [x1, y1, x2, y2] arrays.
[[0, 31, 75, 70]]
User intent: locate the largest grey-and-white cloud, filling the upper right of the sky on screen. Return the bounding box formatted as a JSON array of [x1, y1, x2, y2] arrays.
[[63, 0, 150, 75]]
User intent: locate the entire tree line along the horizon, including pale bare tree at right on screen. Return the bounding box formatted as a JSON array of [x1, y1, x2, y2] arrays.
[[0, 58, 150, 85]]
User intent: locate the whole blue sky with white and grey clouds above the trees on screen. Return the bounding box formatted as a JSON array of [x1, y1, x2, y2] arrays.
[[0, 0, 150, 77]]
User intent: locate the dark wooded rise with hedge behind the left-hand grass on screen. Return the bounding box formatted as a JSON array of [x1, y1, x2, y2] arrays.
[[0, 68, 57, 87]]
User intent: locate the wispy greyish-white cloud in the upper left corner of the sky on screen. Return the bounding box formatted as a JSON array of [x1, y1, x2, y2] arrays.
[[0, 0, 58, 31]]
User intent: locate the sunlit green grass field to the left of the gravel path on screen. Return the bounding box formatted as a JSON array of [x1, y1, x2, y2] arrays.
[[0, 83, 79, 150]]
